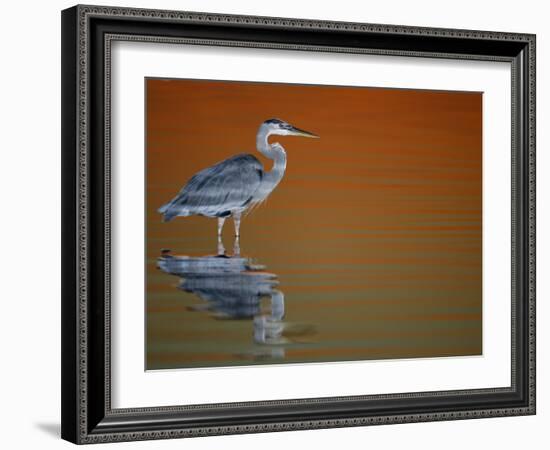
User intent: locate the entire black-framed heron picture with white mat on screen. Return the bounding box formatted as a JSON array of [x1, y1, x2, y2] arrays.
[[62, 6, 535, 444]]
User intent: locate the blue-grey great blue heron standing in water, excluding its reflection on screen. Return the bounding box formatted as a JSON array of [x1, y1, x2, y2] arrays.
[[158, 119, 319, 240]]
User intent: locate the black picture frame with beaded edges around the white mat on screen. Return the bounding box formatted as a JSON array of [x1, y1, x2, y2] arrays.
[[61, 5, 535, 444]]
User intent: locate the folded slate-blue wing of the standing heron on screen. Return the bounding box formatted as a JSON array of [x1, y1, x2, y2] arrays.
[[159, 154, 263, 220]]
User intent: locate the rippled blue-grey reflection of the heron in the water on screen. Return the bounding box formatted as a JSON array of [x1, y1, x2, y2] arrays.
[[158, 246, 315, 358]]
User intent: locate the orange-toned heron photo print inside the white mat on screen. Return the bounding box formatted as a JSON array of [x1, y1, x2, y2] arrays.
[[145, 78, 482, 370]]
